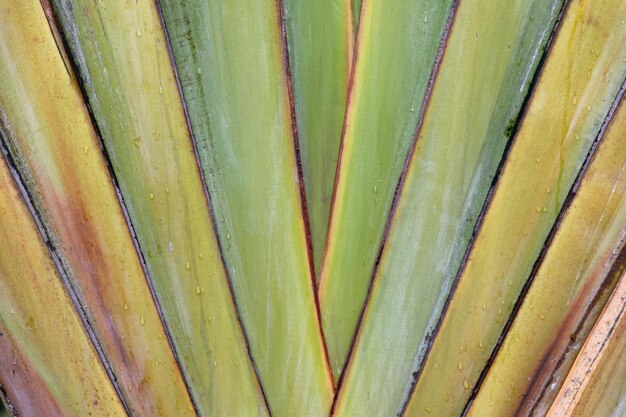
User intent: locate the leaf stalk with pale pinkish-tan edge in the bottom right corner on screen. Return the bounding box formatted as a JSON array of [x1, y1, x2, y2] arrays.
[[547, 266, 626, 417]]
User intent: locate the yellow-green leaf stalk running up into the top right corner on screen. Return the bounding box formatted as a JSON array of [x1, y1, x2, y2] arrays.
[[406, 0, 626, 416]]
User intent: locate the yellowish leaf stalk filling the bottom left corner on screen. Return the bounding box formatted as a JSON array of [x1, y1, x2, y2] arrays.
[[0, 142, 127, 417]]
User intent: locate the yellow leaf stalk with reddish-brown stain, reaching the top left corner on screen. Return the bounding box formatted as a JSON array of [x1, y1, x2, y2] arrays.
[[0, 0, 195, 417]]
